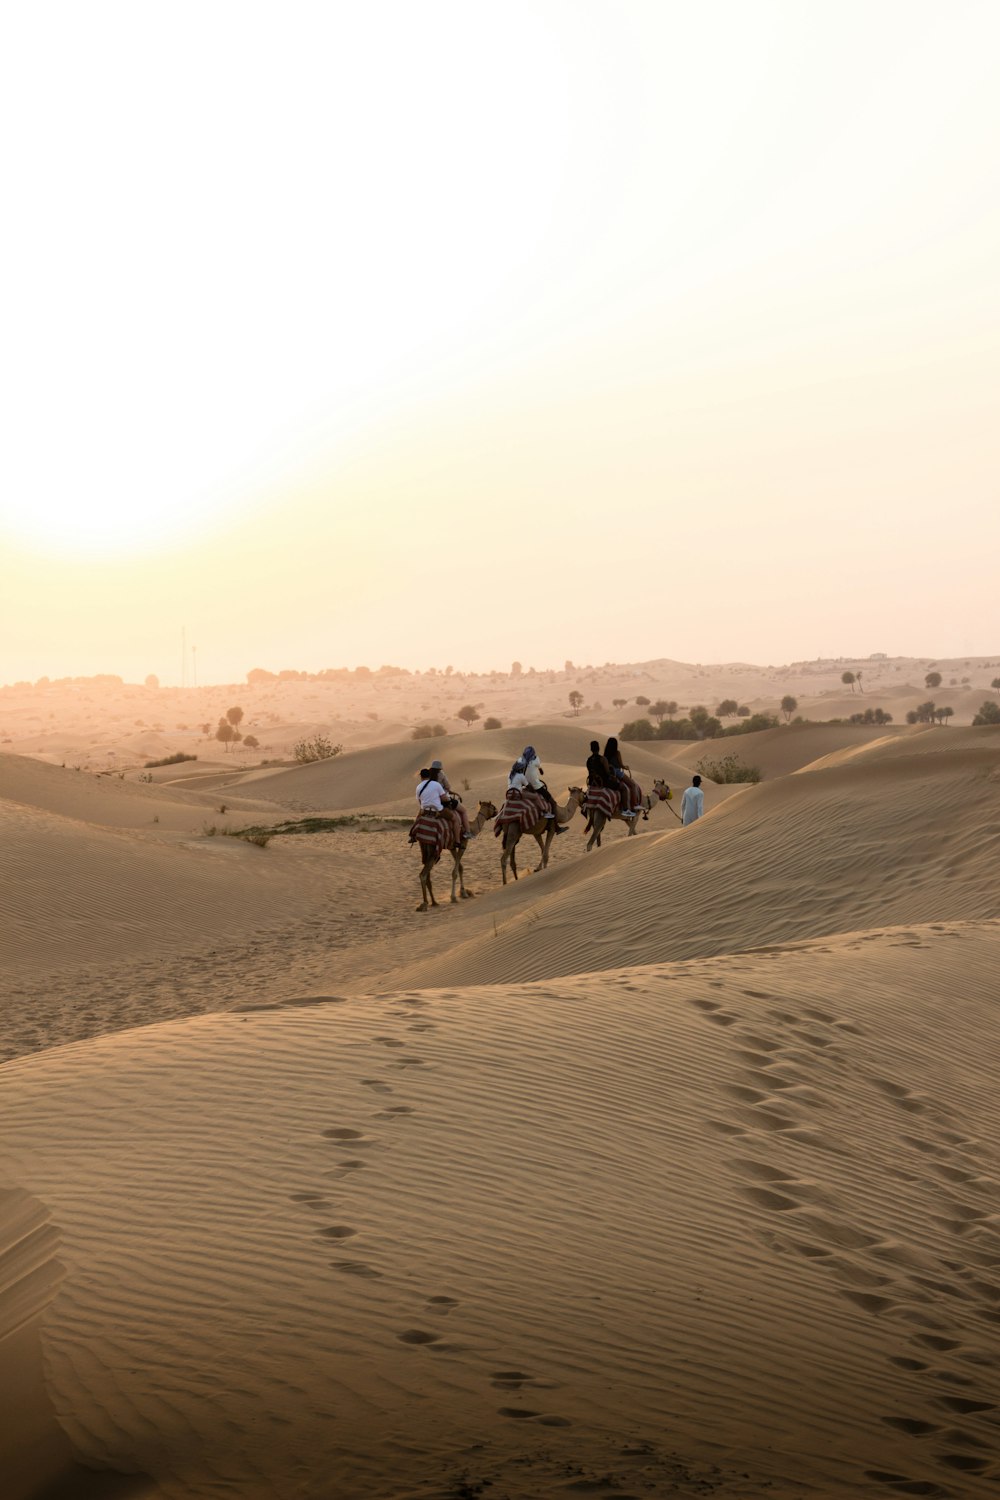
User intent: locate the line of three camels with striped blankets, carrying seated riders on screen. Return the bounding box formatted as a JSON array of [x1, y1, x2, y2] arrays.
[[409, 740, 673, 912]]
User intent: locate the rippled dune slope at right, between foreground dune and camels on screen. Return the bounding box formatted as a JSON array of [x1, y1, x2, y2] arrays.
[[396, 729, 1000, 986]]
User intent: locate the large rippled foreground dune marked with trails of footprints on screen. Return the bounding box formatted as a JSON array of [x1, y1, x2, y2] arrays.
[[1, 924, 1000, 1500]]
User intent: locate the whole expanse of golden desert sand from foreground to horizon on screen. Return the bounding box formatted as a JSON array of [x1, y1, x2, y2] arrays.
[[0, 663, 1000, 1500]]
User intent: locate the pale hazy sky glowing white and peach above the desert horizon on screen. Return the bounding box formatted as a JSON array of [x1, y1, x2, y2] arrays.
[[0, 0, 1000, 681]]
